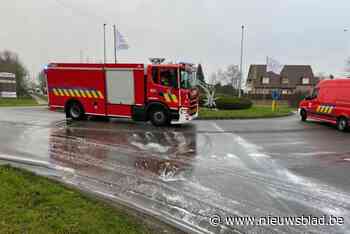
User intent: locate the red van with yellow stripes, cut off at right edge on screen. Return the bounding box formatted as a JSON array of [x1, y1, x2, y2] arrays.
[[299, 79, 350, 131]]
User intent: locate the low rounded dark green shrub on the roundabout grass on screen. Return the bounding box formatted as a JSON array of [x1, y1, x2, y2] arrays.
[[216, 96, 253, 110]]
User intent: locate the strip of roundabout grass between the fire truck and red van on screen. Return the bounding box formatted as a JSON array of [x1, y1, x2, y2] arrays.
[[199, 106, 294, 119]]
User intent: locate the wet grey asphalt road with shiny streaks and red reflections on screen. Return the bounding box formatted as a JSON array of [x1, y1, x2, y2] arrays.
[[0, 107, 350, 233]]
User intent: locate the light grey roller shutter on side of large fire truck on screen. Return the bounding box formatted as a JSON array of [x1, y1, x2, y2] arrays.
[[106, 70, 135, 105]]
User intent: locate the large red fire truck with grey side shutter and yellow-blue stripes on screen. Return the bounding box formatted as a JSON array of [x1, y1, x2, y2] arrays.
[[45, 63, 199, 126]]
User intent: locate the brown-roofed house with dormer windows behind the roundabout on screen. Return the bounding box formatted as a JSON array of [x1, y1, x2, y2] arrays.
[[246, 65, 319, 96]]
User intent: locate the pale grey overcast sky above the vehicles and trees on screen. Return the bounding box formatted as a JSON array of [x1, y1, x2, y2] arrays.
[[0, 0, 350, 82]]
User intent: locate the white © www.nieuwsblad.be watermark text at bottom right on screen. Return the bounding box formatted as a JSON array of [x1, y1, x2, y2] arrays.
[[209, 214, 344, 227]]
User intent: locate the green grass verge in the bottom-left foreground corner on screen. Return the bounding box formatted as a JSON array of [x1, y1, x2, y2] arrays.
[[0, 166, 151, 234]]
